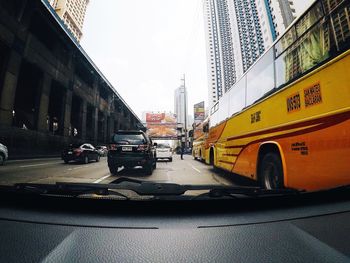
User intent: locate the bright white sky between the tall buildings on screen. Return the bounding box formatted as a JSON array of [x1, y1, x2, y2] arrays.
[[81, 0, 208, 118]]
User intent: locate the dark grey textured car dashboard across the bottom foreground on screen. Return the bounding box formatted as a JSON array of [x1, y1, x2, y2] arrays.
[[0, 192, 350, 262]]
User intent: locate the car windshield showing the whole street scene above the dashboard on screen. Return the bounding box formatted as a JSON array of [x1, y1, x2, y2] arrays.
[[0, 0, 350, 202]]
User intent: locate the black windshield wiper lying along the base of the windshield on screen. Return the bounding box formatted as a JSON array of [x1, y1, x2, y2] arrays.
[[6, 177, 301, 199]]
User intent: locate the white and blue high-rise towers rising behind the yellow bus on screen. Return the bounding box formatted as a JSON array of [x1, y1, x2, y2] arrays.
[[203, 0, 295, 108]]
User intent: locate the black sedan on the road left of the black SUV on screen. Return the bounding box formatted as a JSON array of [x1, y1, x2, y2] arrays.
[[62, 143, 100, 164]]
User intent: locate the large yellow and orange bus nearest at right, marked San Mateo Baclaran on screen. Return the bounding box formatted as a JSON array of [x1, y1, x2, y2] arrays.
[[205, 0, 350, 191]]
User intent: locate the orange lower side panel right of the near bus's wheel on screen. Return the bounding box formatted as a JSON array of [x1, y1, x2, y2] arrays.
[[278, 117, 350, 191]]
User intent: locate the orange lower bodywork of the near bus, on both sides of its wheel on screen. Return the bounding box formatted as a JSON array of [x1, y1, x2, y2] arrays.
[[230, 112, 350, 191]]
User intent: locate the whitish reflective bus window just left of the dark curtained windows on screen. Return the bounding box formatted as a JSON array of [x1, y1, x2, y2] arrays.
[[247, 49, 275, 105]]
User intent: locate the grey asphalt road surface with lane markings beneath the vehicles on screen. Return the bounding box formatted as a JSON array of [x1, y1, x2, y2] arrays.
[[0, 155, 238, 188]]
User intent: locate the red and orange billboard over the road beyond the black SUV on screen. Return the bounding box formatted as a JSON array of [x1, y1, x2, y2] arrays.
[[146, 112, 177, 139]]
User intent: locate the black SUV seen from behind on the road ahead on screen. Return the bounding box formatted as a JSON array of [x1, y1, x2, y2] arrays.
[[107, 131, 157, 175]]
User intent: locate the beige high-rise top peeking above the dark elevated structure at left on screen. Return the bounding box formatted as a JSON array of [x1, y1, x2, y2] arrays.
[[49, 0, 89, 41]]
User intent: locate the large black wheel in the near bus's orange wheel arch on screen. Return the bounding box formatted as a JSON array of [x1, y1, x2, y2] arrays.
[[259, 152, 283, 189]]
